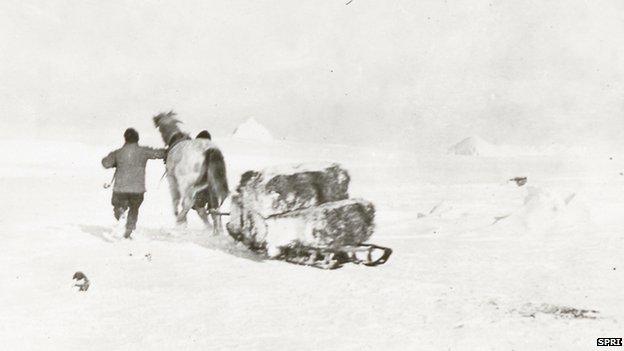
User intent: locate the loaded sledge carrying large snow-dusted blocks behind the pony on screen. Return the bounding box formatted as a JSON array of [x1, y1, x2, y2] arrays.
[[226, 163, 392, 269]]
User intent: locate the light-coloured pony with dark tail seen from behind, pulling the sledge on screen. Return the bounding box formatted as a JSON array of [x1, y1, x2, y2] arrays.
[[153, 111, 229, 234]]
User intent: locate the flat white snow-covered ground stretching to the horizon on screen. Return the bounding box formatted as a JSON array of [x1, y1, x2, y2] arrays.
[[0, 140, 624, 350]]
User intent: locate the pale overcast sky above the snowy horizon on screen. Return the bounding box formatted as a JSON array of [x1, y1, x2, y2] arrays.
[[0, 0, 624, 147]]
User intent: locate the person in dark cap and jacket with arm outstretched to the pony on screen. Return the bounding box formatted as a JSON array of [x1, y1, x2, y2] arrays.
[[102, 128, 165, 238]]
